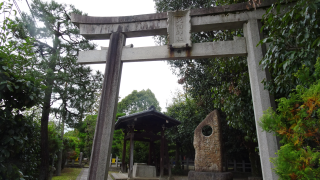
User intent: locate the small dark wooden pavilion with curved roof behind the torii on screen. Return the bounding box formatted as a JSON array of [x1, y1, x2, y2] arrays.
[[115, 106, 180, 178]]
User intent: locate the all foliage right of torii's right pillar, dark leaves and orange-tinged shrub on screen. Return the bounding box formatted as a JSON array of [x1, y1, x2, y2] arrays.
[[261, 0, 320, 179]]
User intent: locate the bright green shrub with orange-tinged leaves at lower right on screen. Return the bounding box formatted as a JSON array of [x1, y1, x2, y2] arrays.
[[260, 58, 320, 180]]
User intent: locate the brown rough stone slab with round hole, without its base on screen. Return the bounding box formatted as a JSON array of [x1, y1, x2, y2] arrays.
[[193, 110, 223, 172]]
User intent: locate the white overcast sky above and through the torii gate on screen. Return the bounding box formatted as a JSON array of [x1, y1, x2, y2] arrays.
[[16, 0, 182, 111]]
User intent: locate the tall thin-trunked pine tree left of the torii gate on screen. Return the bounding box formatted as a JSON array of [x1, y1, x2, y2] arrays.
[[11, 0, 101, 180]]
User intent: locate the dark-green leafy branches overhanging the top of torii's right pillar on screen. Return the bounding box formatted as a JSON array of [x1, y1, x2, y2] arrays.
[[261, 0, 320, 99]]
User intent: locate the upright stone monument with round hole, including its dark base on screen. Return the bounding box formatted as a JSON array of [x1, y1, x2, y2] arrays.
[[188, 110, 233, 180]]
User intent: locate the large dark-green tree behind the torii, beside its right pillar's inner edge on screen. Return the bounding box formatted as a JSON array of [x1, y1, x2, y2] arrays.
[[155, 0, 261, 176]]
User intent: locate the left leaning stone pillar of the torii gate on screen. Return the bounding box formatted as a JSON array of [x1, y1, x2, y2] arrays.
[[88, 28, 126, 180]]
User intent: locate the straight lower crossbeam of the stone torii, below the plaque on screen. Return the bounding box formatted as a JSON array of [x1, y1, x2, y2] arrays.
[[78, 37, 247, 64]]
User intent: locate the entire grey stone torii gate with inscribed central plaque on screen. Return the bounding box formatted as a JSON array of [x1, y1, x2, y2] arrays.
[[71, 0, 278, 180]]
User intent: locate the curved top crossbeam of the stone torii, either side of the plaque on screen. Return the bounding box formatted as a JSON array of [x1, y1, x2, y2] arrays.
[[71, 0, 272, 40]]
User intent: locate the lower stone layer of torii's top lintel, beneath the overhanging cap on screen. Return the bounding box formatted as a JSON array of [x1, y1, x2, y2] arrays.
[[79, 9, 265, 40]]
